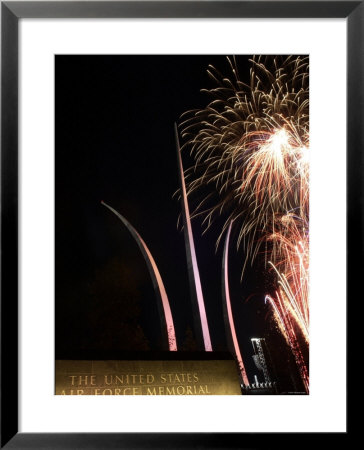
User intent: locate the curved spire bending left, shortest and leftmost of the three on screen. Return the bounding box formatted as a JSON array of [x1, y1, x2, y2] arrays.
[[101, 201, 177, 351]]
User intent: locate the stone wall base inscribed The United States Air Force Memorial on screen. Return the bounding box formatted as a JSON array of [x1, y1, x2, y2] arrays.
[[55, 352, 242, 395]]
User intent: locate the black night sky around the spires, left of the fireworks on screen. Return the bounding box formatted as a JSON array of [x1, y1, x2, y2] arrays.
[[55, 55, 298, 384]]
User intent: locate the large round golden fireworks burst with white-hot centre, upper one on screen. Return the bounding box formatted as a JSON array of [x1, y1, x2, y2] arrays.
[[181, 57, 309, 261]]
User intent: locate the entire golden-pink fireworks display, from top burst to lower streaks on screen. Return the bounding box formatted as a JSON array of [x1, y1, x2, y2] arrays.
[[180, 56, 309, 391]]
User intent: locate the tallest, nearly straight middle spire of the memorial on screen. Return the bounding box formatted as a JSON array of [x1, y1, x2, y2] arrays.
[[174, 124, 212, 352]]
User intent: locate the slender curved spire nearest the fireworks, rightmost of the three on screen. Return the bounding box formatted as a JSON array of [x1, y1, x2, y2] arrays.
[[222, 222, 249, 386]]
